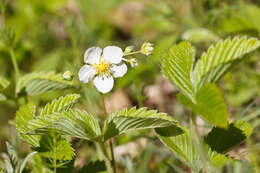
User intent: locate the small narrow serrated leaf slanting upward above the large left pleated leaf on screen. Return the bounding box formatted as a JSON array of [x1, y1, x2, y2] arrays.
[[40, 94, 80, 116]]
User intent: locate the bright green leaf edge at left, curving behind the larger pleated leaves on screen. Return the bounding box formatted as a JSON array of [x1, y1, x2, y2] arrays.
[[15, 103, 40, 147]]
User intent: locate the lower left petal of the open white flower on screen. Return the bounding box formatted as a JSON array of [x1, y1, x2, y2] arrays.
[[78, 65, 96, 83]]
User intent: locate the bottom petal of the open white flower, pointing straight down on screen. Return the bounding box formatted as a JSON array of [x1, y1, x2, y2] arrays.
[[94, 76, 114, 94]]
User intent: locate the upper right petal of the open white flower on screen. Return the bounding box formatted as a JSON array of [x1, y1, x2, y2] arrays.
[[103, 46, 124, 64]]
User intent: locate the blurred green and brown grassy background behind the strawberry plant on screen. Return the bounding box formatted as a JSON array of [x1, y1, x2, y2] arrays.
[[0, 0, 260, 173]]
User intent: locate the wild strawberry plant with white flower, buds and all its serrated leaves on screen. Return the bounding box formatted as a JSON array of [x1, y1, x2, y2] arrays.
[[0, 32, 260, 173]]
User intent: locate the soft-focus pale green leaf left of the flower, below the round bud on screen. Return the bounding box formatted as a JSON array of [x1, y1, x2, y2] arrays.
[[16, 72, 74, 95]]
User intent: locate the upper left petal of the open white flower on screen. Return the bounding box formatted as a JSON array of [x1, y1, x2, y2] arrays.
[[84, 47, 102, 64]]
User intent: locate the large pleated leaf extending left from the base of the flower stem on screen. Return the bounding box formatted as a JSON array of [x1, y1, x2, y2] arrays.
[[28, 110, 101, 140]]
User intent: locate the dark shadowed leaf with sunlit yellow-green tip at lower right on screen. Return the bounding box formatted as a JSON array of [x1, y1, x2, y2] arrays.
[[205, 121, 253, 153]]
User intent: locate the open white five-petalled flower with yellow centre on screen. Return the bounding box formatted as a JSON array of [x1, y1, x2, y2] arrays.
[[78, 46, 127, 94]]
